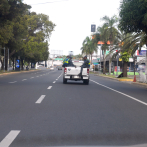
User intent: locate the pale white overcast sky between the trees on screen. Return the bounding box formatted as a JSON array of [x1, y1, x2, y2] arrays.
[[23, 0, 120, 55]]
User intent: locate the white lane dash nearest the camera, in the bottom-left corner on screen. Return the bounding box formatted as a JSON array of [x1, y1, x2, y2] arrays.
[[0, 130, 20, 147]]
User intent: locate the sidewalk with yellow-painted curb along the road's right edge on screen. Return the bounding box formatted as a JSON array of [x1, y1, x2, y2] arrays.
[[93, 73, 147, 88]]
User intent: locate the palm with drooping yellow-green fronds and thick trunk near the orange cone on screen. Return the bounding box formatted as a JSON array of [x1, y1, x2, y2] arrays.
[[112, 32, 141, 77]]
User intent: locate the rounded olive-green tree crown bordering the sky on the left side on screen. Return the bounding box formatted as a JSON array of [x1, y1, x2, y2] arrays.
[[23, 12, 55, 65]]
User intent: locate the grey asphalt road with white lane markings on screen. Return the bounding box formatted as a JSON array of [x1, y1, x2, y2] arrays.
[[0, 69, 147, 147]]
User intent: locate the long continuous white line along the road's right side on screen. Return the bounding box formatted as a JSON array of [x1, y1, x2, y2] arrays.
[[90, 80, 147, 106]]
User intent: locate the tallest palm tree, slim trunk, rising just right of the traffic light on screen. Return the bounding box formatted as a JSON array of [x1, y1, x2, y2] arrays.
[[101, 15, 119, 74]]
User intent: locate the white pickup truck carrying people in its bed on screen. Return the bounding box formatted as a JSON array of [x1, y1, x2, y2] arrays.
[[63, 61, 90, 85]]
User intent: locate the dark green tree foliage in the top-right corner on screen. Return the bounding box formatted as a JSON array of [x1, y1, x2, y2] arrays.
[[119, 0, 147, 34]]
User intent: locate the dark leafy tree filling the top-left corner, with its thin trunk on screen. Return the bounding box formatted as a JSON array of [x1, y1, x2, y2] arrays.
[[0, 0, 31, 69]]
